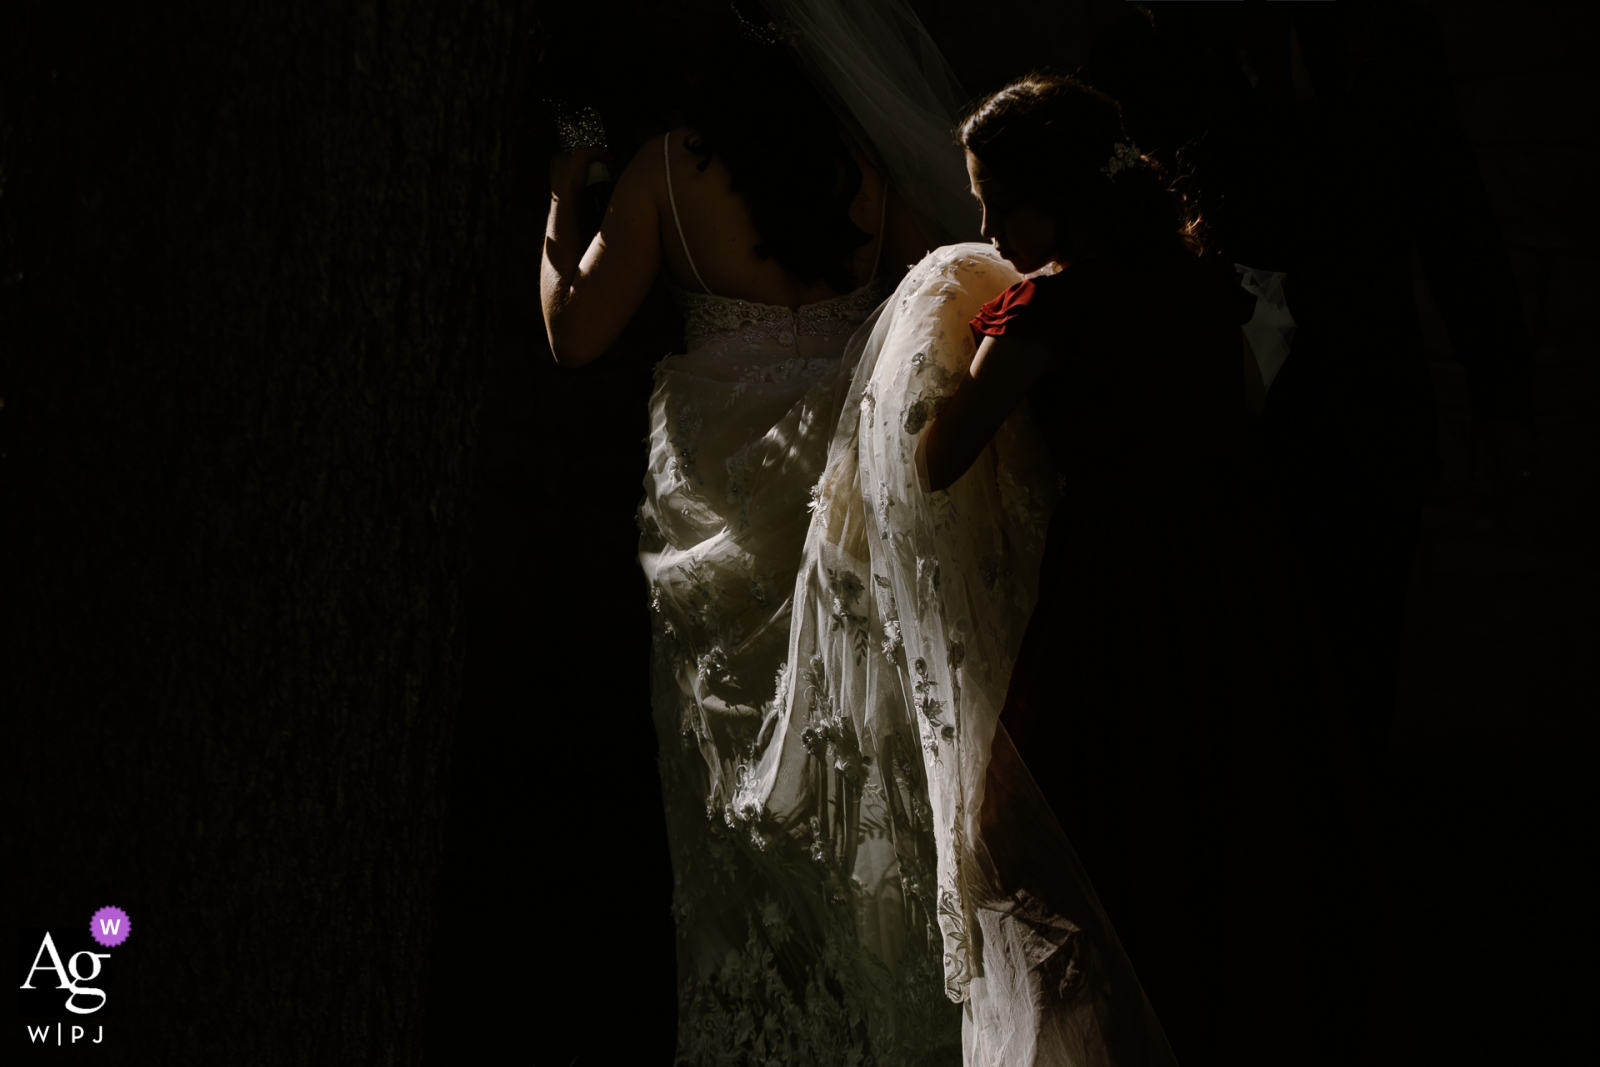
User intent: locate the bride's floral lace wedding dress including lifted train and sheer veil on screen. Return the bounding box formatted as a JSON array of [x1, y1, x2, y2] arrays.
[[638, 0, 1171, 1067]]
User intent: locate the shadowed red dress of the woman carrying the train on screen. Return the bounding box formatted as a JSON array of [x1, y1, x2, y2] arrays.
[[973, 254, 1341, 1067]]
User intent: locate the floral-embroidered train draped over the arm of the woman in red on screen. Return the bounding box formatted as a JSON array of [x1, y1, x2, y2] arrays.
[[761, 243, 1173, 1067]]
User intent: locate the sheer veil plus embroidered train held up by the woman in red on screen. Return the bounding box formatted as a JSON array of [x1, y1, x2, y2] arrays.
[[725, 0, 1173, 1067]]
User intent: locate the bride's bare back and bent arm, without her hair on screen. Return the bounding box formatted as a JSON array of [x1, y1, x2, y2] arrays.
[[539, 126, 931, 366]]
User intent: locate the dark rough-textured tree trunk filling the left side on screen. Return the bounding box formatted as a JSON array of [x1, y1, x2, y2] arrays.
[[0, 0, 526, 1065]]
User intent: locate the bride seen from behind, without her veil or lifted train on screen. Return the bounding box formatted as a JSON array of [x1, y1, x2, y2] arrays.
[[541, 12, 960, 1065]]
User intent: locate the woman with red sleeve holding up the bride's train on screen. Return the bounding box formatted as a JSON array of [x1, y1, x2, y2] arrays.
[[922, 77, 1349, 1065]]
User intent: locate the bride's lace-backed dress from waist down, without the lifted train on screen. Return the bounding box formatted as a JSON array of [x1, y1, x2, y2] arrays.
[[638, 141, 960, 1067]]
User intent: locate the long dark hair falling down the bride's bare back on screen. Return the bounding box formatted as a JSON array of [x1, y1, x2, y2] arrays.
[[683, 19, 870, 293]]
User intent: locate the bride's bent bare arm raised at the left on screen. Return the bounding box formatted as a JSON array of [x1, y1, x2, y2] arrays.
[[539, 141, 662, 366]]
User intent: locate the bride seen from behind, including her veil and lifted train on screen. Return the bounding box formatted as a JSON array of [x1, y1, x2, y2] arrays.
[[541, 0, 1170, 1065]]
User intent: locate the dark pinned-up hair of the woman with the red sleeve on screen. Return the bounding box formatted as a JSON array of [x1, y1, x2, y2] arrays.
[[960, 74, 1202, 259]]
